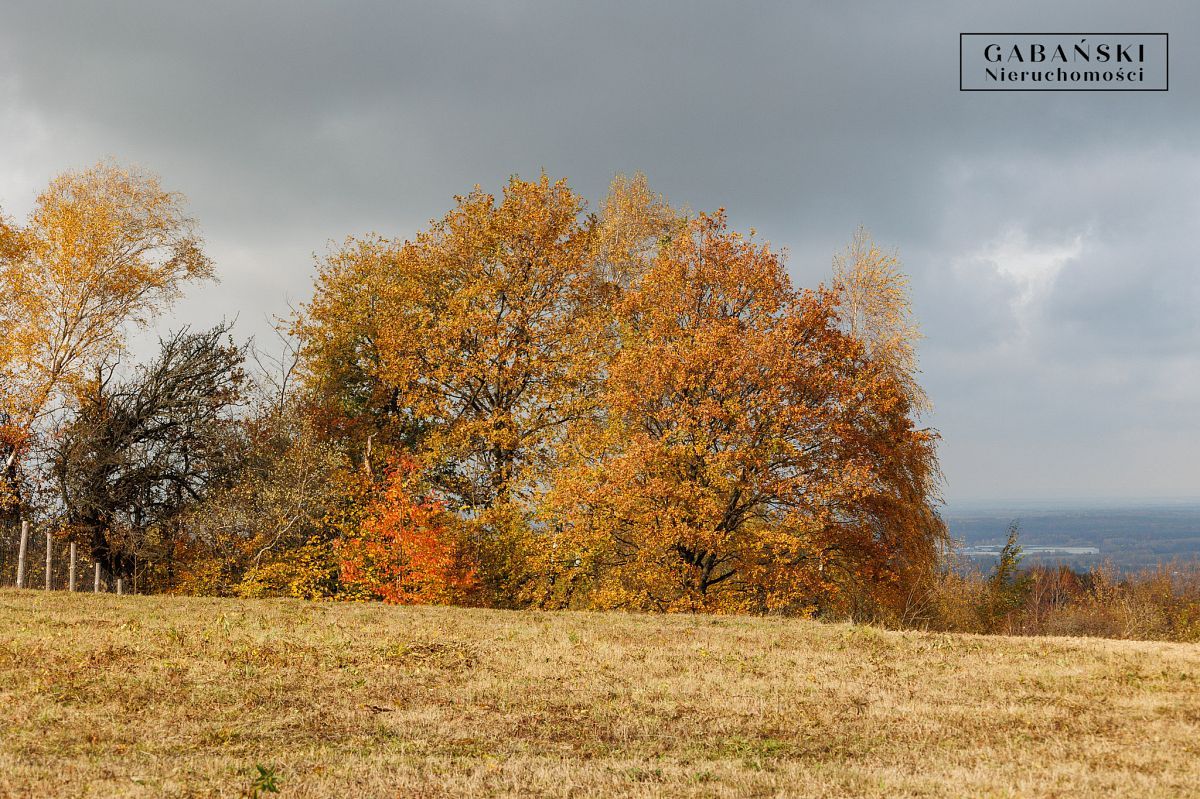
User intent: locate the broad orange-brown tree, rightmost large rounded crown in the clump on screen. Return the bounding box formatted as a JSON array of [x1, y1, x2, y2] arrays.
[[547, 214, 937, 612]]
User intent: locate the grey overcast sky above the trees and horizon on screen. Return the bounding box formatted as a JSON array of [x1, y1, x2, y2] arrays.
[[0, 0, 1200, 503]]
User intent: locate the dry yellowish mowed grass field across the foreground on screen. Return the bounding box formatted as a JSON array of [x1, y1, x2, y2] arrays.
[[0, 590, 1200, 797]]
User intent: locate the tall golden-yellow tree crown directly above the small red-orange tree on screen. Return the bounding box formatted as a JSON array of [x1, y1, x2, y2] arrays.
[[380, 176, 601, 510]]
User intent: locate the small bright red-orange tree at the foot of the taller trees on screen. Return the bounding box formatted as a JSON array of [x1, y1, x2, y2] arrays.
[[337, 459, 476, 605]]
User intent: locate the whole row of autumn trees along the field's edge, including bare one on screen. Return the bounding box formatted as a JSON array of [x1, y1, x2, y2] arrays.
[[0, 164, 946, 613]]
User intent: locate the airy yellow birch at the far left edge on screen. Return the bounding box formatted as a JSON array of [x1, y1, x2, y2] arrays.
[[0, 162, 212, 523]]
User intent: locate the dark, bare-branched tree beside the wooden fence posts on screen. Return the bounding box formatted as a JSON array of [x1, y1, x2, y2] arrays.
[[53, 324, 245, 577]]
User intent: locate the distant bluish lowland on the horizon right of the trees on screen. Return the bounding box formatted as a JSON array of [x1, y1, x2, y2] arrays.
[[943, 499, 1200, 572]]
